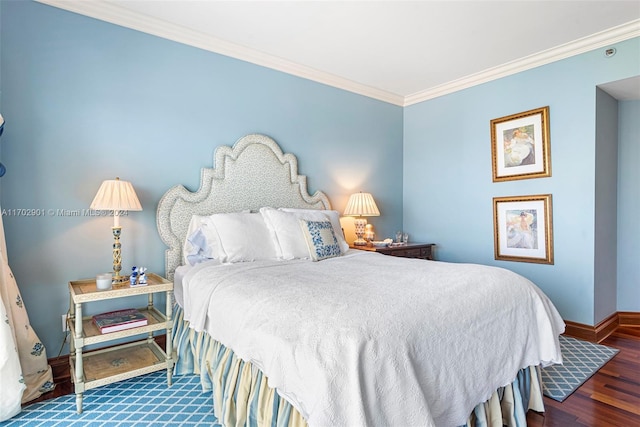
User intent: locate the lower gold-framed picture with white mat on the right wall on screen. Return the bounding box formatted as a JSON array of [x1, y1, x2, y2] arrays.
[[493, 194, 553, 264]]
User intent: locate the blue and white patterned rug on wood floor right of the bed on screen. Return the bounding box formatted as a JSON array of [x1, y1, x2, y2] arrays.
[[542, 335, 620, 402]]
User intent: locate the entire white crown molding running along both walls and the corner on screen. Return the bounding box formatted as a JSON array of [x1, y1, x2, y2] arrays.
[[35, 0, 640, 107]]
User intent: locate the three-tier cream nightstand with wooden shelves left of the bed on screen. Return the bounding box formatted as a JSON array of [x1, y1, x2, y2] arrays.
[[67, 273, 173, 414]]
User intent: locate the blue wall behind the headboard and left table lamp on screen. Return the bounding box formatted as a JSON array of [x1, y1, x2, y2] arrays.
[[0, 2, 402, 357]]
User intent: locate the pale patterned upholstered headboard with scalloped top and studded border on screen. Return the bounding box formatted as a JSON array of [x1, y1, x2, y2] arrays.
[[156, 134, 331, 280]]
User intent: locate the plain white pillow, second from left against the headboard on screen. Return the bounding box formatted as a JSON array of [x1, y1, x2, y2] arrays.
[[207, 212, 277, 263]]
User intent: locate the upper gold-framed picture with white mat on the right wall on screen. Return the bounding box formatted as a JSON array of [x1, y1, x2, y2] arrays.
[[491, 107, 551, 182]]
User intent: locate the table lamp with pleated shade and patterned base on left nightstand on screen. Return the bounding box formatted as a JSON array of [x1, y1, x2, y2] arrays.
[[91, 178, 142, 285]]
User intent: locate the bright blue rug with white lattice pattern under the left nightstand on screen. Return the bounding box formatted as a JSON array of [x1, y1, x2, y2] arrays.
[[0, 371, 216, 427]]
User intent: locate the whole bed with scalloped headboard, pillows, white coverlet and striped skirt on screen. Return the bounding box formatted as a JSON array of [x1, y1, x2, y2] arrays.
[[157, 134, 564, 426]]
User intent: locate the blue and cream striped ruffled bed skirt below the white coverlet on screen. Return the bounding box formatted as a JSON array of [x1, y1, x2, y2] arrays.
[[173, 304, 544, 427]]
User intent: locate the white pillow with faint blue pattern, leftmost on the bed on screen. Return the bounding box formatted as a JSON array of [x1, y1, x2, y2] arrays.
[[182, 215, 225, 265]]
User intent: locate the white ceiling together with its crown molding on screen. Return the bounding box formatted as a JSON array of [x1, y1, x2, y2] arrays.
[[39, 0, 640, 105]]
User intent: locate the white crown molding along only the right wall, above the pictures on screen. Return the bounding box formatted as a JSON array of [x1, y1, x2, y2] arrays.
[[403, 19, 640, 107]]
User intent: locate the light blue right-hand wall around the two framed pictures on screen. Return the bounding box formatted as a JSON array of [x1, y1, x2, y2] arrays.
[[403, 38, 640, 325]]
